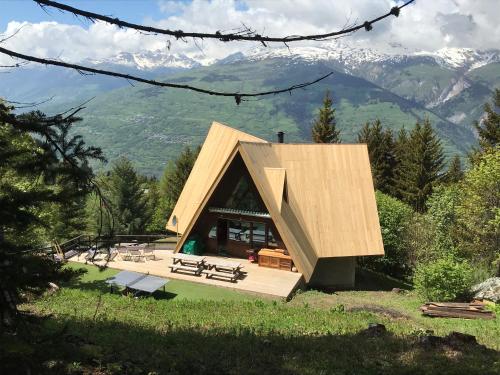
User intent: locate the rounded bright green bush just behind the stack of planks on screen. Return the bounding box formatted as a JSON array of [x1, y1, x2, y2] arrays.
[[413, 256, 473, 301]]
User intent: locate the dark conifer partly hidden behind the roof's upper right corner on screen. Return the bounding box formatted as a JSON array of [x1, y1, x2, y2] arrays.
[[358, 120, 396, 193]]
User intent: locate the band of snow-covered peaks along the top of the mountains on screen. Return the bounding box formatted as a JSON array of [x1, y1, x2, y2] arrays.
[[82, 41, 500, 73]]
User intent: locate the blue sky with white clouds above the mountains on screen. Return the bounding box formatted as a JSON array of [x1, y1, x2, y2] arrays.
[[0, 0, 500, 63]]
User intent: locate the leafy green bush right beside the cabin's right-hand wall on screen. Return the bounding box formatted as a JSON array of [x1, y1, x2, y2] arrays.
[[361, 191, 413, 277]]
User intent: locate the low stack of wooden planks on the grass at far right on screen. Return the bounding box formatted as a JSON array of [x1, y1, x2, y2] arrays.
[[420, 301, 495, 319]]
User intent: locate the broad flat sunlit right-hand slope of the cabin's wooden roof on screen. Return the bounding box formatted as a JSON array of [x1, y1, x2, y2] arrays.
[[242, 142, 384, 258]]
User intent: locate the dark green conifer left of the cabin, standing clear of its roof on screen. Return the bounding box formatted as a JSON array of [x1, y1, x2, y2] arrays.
[[107, 157, 151, 234]]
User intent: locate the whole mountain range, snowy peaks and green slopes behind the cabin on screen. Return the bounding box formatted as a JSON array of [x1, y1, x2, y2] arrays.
[[0, 41, 500, 175]]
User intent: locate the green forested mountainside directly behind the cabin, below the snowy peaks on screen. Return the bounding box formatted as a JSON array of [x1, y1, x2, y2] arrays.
[[72, 58, 473, 175]]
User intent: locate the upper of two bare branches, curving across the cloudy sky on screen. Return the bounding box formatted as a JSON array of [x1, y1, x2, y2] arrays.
[[33, 0, 415, 45]]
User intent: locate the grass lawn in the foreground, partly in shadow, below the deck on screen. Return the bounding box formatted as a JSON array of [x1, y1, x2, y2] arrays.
[[0, 269, 500, 375]]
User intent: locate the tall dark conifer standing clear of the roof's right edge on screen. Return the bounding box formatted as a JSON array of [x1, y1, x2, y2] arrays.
[[397, 119, 444, 212]]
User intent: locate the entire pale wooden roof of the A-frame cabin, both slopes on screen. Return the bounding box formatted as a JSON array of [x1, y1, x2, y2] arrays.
[[167, 123, 384, 281]]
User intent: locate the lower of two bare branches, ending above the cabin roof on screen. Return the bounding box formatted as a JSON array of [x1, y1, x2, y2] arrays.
[[0, 47, 333, 104]]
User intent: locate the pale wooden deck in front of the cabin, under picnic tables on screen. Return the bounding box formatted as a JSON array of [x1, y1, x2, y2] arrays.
[[70, 250, 302, 298]]
